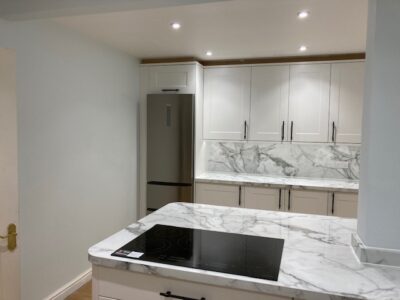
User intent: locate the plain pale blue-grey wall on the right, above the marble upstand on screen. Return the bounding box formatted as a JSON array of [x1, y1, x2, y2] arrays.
[[358, 0, 400, 249]]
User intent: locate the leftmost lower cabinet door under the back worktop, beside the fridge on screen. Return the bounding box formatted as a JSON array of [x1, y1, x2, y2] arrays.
[[196, 183, 241, 207]]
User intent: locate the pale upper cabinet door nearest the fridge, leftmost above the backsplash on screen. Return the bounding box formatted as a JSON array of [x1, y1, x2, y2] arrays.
[[204, 67, 251, 140]]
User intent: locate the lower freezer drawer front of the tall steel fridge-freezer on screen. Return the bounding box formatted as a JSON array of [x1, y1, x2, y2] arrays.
[[147, 182, 193, 212]]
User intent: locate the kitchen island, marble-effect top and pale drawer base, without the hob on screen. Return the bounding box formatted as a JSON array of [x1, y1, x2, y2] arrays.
[[89, 203, 400, 300]]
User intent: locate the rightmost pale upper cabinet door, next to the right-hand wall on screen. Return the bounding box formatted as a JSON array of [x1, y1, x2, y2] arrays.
[[329, 62, 364, 143]]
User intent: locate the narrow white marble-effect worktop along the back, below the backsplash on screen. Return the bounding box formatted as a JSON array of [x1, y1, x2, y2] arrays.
[[195, 172, 358, 193]]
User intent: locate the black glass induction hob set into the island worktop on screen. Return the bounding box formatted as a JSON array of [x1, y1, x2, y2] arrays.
[[112, 225, 284, 281]]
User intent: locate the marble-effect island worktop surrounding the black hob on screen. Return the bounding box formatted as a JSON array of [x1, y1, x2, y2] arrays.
[[89, 203, 400, 300]]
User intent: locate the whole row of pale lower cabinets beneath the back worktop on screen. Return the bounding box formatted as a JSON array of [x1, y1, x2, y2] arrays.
[[195, 183, 358, 218]]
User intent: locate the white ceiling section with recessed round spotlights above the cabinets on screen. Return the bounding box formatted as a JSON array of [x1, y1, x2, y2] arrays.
[[55, 0, 368, 59]]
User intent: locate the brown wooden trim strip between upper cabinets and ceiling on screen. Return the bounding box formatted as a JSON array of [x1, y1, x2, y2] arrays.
[[141, 52, 365, 66]]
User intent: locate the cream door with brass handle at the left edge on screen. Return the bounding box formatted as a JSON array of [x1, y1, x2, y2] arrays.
[[0, 49, 20, 300]]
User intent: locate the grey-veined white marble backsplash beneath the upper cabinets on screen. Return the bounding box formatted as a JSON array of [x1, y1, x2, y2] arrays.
[[205, 141, 360, 180]]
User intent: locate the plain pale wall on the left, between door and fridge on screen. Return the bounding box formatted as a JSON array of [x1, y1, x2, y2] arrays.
[[0, 20, 139, 300]]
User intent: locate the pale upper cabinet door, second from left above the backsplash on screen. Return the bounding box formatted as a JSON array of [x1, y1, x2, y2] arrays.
[[250, 66, 289, 141]]
